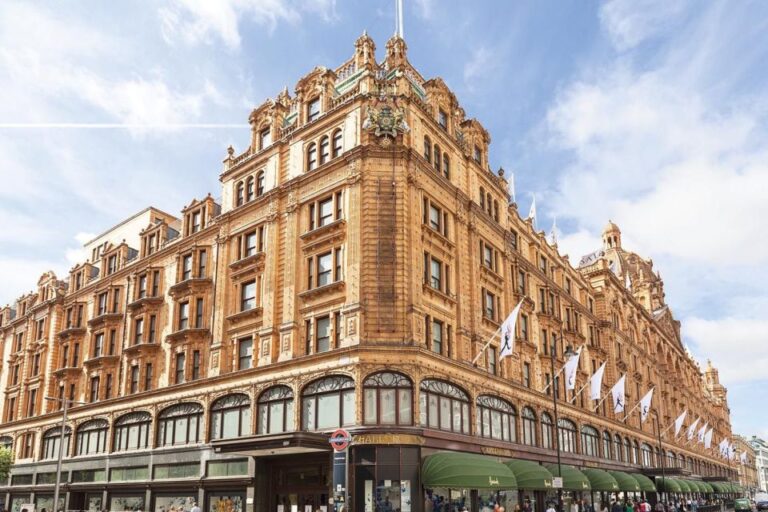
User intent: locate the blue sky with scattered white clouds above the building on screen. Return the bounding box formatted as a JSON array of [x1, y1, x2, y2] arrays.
[[0, 0, 768, 438]]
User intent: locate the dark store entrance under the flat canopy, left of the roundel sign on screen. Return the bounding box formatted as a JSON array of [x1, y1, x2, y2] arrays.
[[267, 453, 332, 512]]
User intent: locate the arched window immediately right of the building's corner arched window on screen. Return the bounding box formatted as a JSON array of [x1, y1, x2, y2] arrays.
[[419, 379, 470, 434]]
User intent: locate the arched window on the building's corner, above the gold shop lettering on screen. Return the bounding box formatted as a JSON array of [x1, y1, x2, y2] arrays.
[[363, 372, 413, 425]]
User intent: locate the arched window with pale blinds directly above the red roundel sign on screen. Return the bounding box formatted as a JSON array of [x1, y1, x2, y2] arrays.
[[301, 375, 355, 430]]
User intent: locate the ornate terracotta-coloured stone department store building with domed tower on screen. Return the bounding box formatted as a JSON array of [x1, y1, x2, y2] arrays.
[[0, 34, 735, 512]]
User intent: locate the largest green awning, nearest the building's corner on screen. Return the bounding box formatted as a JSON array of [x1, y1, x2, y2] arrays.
[[421, 452, 517, 489]]
